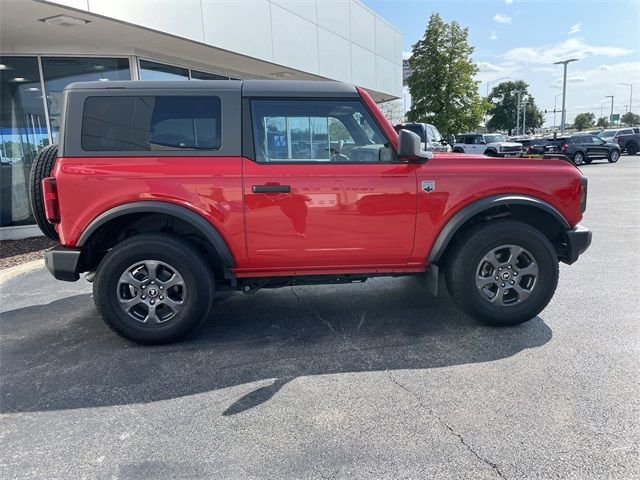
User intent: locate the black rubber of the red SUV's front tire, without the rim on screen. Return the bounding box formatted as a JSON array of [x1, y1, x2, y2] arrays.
[[454, 221, 558, 325]]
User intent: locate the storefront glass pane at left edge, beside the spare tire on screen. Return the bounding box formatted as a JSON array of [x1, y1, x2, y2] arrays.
[[0, 57, 49, 227]]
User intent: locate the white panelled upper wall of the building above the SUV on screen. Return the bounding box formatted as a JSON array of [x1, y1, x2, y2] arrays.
[[49, 0, 402, 97]]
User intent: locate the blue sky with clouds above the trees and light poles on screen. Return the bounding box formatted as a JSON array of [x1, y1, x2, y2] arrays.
[[363, 0, 640, 126]]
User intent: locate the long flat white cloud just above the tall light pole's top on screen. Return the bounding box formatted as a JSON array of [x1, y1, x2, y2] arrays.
[[503, 38, 633, 64]]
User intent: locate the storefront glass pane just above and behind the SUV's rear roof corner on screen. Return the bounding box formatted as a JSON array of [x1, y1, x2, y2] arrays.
[[42, 57, 131, 143]]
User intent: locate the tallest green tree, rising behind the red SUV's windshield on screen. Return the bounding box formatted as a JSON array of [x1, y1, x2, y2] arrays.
[[407, 13, 487, 135]]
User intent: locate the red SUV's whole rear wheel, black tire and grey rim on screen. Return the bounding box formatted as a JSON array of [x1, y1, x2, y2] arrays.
[[93, 233, 214, 344]]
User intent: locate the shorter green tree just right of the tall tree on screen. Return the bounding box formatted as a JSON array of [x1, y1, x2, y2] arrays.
[[487, 80, 544, 133]]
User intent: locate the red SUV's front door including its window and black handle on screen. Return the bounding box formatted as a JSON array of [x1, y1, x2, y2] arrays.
[[243, 99, 417, 271]]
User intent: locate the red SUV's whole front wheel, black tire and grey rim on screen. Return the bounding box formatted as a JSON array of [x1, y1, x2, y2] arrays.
[[445, 220, 558, 326]]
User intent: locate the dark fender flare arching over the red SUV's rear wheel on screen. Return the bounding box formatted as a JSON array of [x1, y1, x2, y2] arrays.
[[76, 200, 236, 272]]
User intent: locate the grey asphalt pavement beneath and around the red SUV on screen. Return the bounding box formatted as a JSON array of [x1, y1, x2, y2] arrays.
[[0, 155, 640, 480]]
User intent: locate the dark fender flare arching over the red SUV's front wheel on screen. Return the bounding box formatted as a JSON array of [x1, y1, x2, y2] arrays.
[[429, 194, 571, 264]]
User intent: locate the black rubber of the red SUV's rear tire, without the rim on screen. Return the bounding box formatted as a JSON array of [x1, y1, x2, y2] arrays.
[[94, 235, 214, 344]]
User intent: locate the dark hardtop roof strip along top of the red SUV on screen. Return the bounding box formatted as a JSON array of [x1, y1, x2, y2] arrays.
[[66, 80, 358, 97]]
